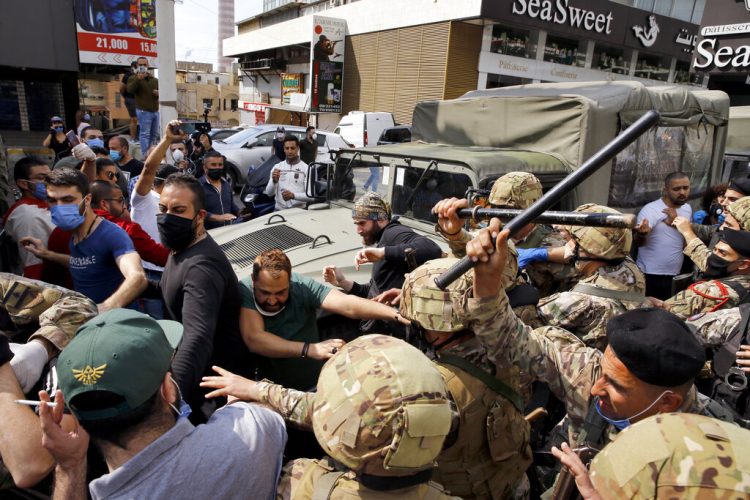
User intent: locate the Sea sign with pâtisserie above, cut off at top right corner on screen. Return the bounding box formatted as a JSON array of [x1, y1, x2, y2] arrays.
[[693, 0, 750, 73]]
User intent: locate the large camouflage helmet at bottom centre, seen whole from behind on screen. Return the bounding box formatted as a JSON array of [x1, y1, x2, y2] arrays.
[[312, 335, 452, 476]]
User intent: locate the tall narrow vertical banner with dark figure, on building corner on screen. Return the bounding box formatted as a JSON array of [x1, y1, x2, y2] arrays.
[[310, 16, 346, 113]]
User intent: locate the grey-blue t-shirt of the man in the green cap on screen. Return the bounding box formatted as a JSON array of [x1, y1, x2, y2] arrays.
[[89, 403, 286, 499]]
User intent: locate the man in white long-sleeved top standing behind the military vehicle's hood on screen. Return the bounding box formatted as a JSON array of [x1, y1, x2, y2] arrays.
[[265, 135, 312, 212]]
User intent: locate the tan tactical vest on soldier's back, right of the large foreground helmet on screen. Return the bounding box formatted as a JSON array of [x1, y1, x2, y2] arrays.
[[434, 362, 531, 499]]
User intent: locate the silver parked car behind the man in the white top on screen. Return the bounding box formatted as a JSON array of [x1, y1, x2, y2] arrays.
[[213, 125, 352, 186]]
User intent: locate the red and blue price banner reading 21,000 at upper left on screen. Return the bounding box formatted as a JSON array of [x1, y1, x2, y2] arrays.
[[75, 0, 157, 67]]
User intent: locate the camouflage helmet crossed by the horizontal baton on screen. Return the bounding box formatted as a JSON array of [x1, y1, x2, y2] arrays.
[[564, 203, 633, 260]]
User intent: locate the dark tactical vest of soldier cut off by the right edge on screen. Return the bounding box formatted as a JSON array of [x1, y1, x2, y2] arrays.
[[711, 304, 750, 428]]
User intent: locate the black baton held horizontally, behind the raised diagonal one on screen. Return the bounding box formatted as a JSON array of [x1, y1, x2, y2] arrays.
[[458, 206, 636, 229]]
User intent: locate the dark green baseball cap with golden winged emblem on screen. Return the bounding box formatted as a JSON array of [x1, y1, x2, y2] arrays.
[[57, 309, 182, 420]]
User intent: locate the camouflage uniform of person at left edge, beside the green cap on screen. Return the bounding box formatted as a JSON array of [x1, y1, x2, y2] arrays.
[[0, 273, 97, 490]]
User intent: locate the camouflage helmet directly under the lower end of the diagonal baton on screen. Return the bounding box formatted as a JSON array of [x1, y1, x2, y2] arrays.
[[399, 256, 518, 332]]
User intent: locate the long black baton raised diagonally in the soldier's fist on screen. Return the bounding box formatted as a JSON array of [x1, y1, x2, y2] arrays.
[[435, 109, 659, 290]]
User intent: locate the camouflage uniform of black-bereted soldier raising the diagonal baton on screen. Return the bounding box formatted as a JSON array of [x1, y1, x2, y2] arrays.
[[466, 292, 707, 446]]
